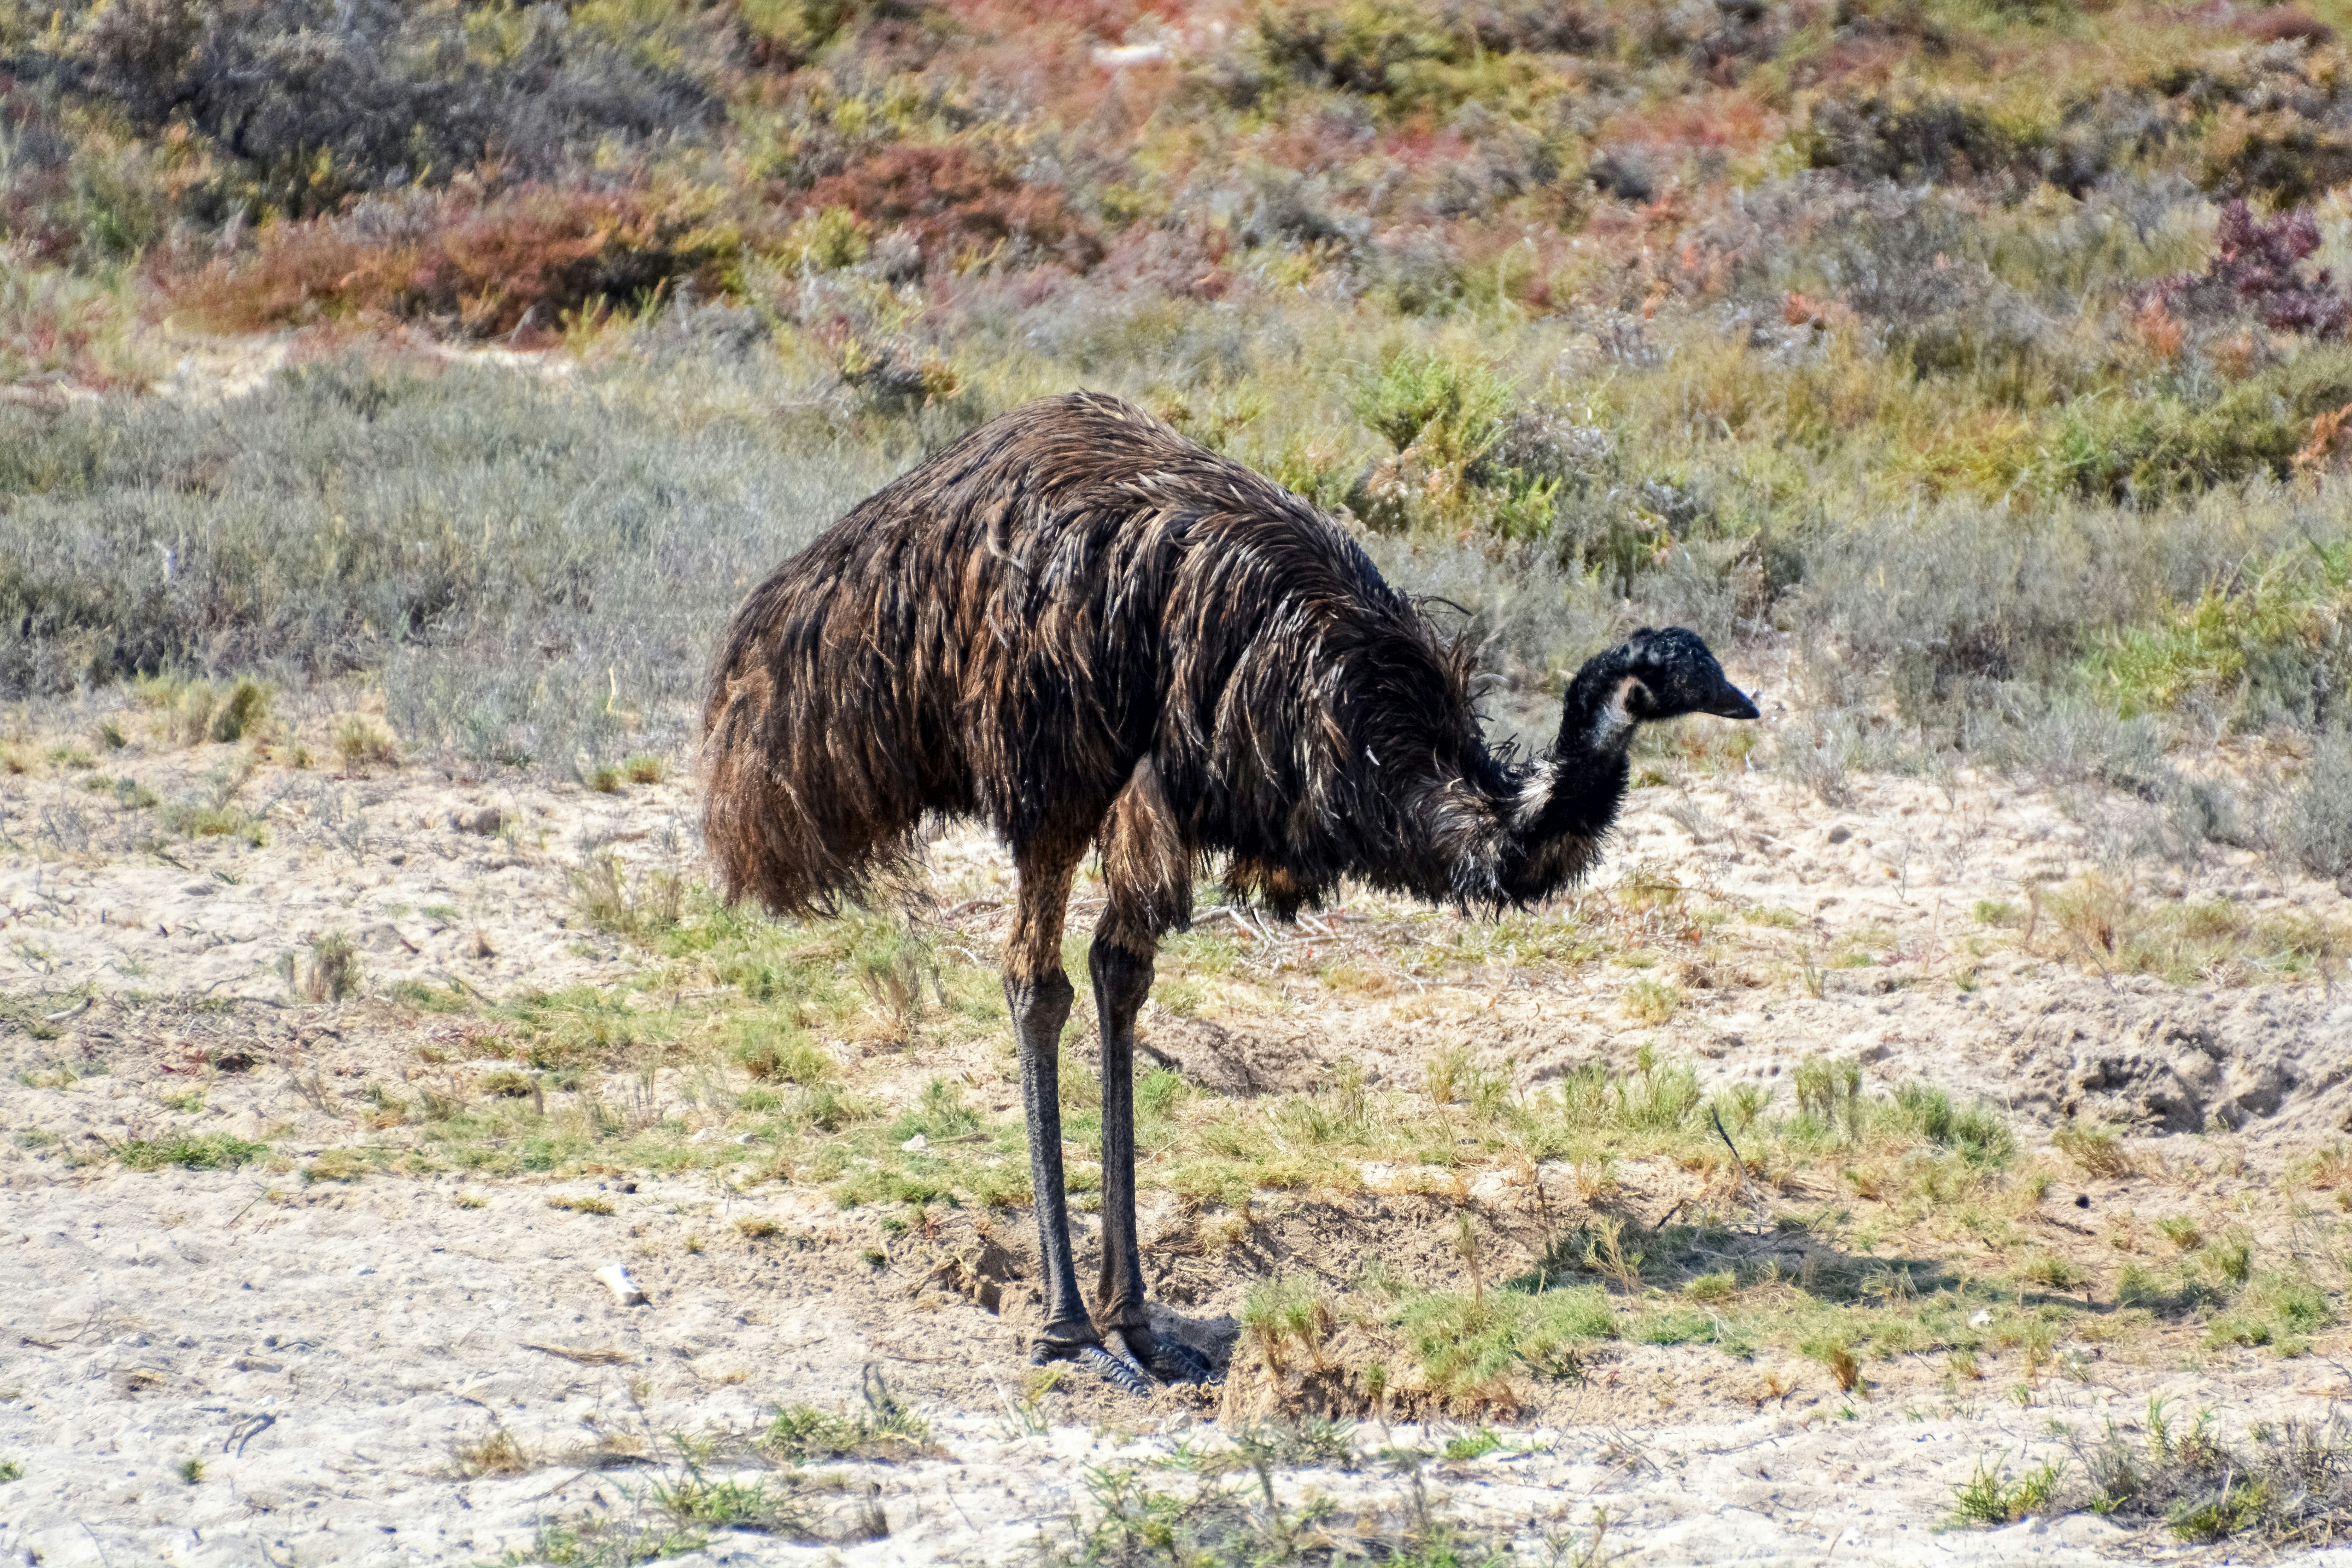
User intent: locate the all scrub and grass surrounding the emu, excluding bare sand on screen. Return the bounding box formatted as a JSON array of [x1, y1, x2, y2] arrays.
[[0, 0, 2352, 1568]]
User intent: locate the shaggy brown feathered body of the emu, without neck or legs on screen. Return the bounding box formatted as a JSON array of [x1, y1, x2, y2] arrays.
[[703, 393, 1493, 912]]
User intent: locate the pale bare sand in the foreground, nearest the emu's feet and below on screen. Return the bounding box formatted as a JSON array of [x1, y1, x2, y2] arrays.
[[0, 1175, 2323, 1563]]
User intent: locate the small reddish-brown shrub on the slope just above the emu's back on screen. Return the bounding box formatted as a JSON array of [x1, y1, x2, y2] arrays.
[[807, 146, 1103, 273]]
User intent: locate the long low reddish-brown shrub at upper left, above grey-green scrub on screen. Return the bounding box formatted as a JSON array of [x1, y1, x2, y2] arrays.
[[172, 188, 736, 336]]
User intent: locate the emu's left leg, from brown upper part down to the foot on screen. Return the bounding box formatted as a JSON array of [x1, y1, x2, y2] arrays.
[[1004, 853, 1150, 1394]]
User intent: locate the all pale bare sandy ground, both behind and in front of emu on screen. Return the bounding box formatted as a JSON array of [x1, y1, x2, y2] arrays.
[[0, 715, 2352, 1565]]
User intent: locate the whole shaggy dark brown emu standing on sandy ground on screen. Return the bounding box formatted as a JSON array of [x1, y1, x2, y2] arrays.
[[703, 393, 1757, 1394]]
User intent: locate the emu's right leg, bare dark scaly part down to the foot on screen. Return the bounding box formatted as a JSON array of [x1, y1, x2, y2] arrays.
[[1087, 933, 1211, 1382]]
